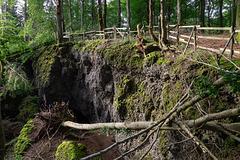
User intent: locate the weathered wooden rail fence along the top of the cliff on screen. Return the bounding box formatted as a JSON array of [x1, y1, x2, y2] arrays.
[[64, 25, 240, 57]]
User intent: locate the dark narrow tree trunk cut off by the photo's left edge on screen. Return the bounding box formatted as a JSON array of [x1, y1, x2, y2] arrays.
[[0, 61, 5, 160]]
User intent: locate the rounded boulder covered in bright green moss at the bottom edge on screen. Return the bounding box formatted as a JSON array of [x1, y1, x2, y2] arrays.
[[55, 141, 86, 160]]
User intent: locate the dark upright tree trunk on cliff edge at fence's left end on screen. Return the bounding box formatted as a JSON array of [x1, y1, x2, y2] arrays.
[[56, 0, 63, 43]]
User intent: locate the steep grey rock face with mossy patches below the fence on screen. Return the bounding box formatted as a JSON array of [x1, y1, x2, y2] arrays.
[[34, 41, 240, 159]]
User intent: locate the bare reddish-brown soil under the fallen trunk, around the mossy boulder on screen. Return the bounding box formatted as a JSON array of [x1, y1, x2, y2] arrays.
[[6, 120, 120, 160]]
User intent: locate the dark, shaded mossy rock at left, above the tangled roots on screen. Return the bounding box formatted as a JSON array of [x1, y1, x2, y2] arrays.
[[17, 96, 39, 121]]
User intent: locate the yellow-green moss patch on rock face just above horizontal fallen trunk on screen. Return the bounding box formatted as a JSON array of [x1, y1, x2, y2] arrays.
[[115, 76, 154, 120]]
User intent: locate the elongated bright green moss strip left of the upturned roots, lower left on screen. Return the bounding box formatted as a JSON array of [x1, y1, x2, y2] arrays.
[[14, 119, 36, 154]]
